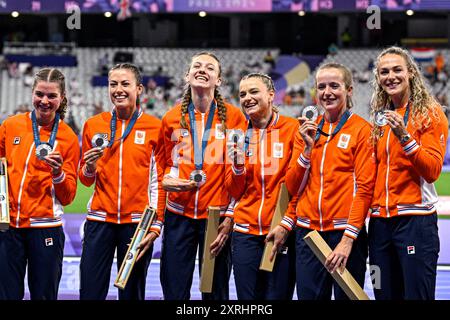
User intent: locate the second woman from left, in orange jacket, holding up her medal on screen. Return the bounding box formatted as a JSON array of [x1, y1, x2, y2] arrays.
[[78, 63, 165, 300]]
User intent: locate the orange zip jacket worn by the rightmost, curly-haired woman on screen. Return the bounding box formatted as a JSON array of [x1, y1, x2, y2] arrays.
[[371, 106, 448, 218]]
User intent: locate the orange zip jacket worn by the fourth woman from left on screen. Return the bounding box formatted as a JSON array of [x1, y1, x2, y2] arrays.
[[226, 113, 298, 236]]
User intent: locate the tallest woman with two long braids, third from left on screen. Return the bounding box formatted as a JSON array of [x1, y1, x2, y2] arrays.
[[160, 52, 245, 300]]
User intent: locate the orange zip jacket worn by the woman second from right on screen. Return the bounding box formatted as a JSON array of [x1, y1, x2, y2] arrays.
[[281, 114, 376, 239]]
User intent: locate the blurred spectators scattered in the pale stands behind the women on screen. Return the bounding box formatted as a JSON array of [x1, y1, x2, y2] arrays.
[[0, 47, 450, 133]]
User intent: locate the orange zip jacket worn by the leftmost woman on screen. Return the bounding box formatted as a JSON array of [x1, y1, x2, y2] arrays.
[[0, 112, 80, 228]]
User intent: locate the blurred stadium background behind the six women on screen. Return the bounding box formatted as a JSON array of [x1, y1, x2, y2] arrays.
[[0, 0, 450, 299]]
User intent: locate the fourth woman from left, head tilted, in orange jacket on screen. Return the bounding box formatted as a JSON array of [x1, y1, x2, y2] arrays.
[[226, 73, 298, 300]]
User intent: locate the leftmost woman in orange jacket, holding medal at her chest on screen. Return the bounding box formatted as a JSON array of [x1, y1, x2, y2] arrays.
[[0, 68, 80, 300]]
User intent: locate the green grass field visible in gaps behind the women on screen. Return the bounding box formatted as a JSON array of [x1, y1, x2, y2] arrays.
[[65, 172, 450, 213]]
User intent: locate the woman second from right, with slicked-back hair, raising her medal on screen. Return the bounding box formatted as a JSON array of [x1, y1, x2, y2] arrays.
[[278, 63, 376, 300]]
